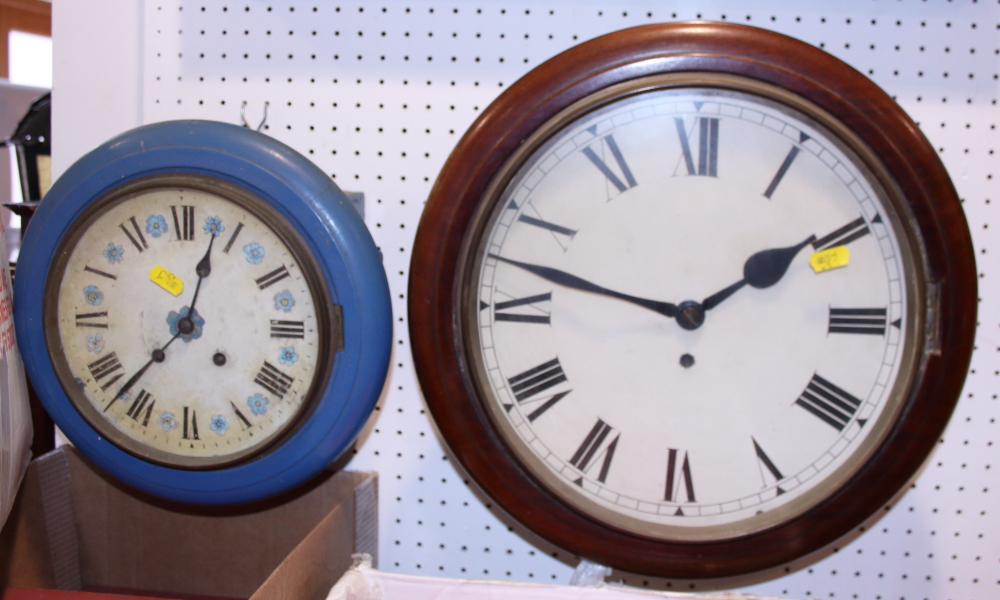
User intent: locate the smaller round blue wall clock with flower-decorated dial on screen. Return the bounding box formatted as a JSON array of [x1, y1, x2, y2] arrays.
[[15, 121, 392, 504]]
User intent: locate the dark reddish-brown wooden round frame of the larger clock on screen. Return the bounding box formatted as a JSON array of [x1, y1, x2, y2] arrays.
[[409, 22, 977, 578]]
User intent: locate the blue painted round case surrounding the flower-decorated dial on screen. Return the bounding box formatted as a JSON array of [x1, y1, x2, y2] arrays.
[[14, 121, 392, 505]]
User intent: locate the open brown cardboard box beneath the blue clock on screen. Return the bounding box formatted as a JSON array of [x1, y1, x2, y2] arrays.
[[0, 446, 378, 600]]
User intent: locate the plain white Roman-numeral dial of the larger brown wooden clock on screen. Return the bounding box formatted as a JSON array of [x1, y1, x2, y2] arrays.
[[465, 78, 918, 540]]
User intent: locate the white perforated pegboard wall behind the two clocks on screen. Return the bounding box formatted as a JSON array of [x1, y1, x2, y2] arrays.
[[54, 0, 1000, 600]]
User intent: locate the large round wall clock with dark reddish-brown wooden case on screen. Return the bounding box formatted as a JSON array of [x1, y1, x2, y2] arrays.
[[409, 22, 976, 578]]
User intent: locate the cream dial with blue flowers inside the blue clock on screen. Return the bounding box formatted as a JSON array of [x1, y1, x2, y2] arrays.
[[48, 178, 328, 468]]
